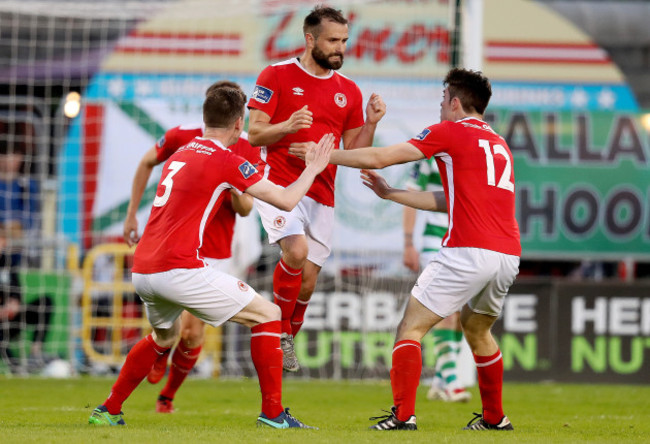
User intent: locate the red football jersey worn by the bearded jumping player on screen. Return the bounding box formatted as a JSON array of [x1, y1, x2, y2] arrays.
[[248, 59, 363, 206]]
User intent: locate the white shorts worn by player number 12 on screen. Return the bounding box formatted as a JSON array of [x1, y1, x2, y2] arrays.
[[411, 247, 519, 318]]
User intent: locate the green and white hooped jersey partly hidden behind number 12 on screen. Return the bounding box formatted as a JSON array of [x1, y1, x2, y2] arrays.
[[407, 158, 449, 263]]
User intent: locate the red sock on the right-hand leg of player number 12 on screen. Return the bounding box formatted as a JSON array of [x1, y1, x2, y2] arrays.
[[474, 350, 503, 424]]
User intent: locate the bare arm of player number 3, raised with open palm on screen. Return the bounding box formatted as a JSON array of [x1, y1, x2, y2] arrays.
[[246, 133, 335, 211]]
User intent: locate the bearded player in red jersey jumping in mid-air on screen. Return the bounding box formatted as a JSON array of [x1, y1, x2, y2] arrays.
[[248, 6, 386, 372]]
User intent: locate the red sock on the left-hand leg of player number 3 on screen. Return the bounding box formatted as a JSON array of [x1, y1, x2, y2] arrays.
[[104, 335, 169, 415]]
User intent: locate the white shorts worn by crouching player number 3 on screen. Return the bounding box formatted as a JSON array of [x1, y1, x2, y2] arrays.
[[133, 266, 257, 328]]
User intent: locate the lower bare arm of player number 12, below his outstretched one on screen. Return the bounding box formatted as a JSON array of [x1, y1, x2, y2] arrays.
[[361, 169, 447, 213]]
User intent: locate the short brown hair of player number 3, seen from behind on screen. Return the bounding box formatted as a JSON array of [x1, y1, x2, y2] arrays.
[[203, 87, 246, 128]]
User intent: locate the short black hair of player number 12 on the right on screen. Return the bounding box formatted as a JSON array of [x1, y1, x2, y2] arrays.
[[443, 68, 492, 114]]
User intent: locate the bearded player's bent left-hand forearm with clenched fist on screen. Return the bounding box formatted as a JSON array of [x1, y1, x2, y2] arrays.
[[248, 105, 314, 146]]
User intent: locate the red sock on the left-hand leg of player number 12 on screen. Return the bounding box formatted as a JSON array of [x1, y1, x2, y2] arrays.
[[390, 340, 422, 421]]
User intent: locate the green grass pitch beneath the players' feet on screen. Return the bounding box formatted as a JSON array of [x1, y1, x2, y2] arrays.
[[0, 377, 650, 444]]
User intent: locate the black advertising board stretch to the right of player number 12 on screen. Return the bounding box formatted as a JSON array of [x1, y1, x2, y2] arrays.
[[494, 283, 650, 384]]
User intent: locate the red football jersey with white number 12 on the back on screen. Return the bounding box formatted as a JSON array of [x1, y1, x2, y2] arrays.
[[409, 118, 521, 256]]
